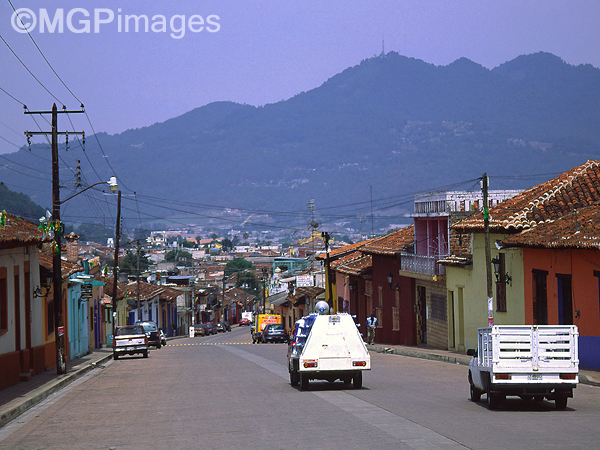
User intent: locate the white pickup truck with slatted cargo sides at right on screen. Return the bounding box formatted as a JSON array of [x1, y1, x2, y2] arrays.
[[467, 325, 579, 409]]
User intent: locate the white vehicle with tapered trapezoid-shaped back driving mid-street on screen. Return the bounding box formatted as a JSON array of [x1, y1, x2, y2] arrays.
[[288, 310, 371, 390]]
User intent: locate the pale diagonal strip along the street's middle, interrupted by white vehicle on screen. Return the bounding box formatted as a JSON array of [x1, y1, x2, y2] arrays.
[[223, 347, 467, 450]]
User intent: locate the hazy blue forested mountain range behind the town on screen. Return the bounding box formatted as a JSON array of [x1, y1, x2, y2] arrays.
[[0, 52, 600, 230]]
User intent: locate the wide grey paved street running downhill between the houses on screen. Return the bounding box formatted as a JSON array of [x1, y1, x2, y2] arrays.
[[0, 327, 600, 450]]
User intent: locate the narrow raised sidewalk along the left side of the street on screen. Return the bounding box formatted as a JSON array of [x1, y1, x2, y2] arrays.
[[0, 348, 112, 428]]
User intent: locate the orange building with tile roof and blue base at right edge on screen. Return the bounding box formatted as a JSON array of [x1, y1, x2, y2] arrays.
[[503, 204, 600, 369]]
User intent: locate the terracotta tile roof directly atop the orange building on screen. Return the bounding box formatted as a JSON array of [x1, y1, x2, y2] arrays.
[[502, 204, 600, 249]]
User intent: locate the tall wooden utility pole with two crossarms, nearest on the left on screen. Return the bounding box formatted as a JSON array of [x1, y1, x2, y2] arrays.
[[25, 103, 85, 375]]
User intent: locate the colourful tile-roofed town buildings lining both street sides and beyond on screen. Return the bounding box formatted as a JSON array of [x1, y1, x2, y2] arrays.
[[0, 160, 600, 388]]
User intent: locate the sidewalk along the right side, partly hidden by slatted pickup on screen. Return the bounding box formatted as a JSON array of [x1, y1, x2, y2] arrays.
[[367, 343, 600, 386]]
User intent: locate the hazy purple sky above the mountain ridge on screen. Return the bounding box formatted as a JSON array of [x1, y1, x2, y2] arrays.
[[0, 0, 600, 152]]
